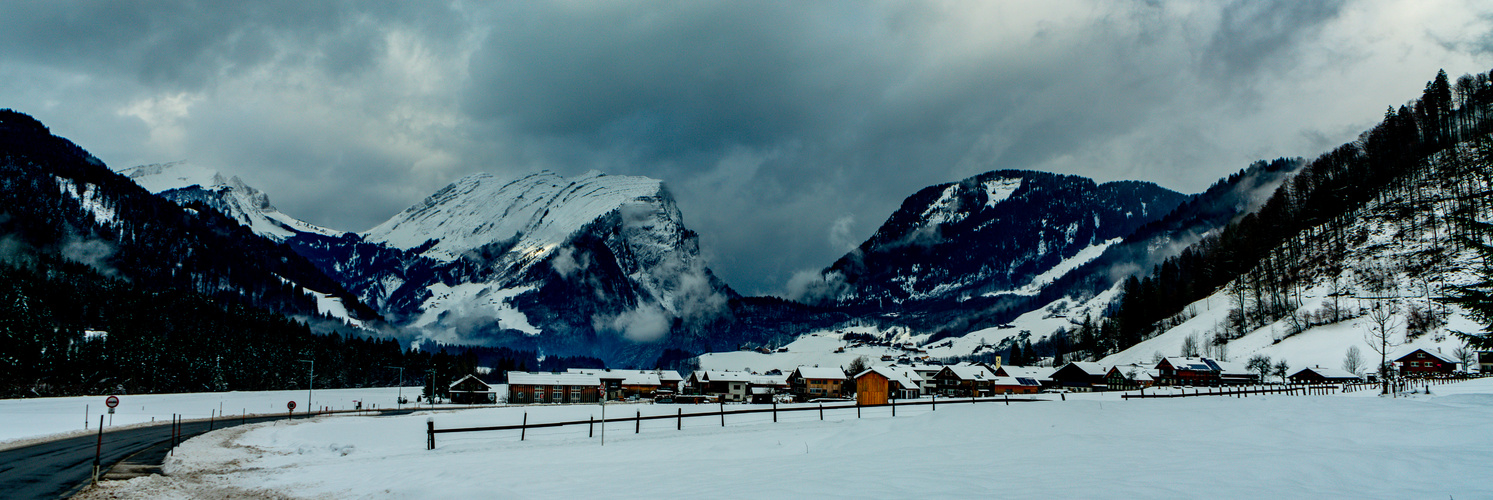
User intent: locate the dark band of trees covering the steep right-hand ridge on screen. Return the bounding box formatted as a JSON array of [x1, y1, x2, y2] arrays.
[[1057, 72, 1493, 358]]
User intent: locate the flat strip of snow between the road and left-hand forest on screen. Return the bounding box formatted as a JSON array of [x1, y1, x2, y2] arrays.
[[0, 387, 421, 449]]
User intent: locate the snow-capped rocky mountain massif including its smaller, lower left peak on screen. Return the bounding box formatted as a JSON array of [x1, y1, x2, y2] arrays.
[[124, 163, 733, 363]]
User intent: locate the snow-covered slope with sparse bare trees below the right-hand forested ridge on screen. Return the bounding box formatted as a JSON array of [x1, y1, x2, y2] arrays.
[[1100, 140, 1493, 372]]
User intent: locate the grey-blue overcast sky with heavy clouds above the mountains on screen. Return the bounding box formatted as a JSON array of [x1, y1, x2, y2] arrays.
[[0, 0, 1493, 294]]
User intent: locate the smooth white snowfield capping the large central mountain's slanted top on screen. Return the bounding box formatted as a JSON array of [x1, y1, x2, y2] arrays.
[[363, 170, 664, 260]]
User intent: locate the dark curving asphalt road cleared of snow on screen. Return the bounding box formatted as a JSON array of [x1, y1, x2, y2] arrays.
[[0, 415, 285, 499]]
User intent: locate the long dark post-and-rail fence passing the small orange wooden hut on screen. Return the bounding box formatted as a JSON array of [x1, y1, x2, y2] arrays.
[[426, 394, 1050, 449]]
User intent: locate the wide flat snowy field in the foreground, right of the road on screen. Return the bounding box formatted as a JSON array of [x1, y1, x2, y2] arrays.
[[75, 379, 1493, 499]]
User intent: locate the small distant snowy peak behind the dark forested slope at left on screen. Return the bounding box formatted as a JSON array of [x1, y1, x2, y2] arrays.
[[119, 161, 339, 242]]
